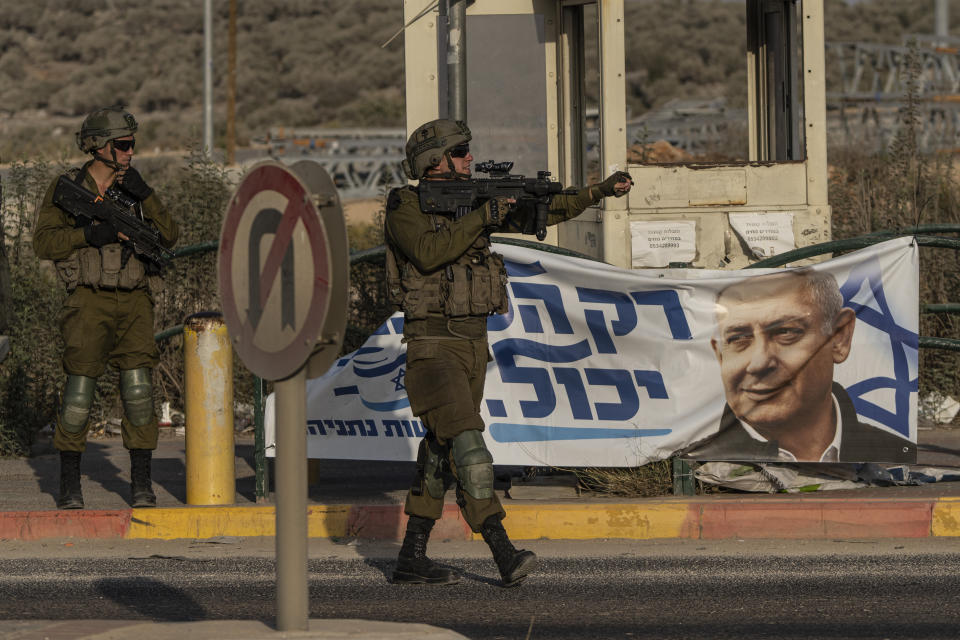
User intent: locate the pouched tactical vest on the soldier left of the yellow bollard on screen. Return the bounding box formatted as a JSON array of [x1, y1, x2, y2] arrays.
[[53, 167, 148, 291]]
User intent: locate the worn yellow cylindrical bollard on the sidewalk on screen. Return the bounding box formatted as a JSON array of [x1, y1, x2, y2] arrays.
[[183, 313, 236, 504]]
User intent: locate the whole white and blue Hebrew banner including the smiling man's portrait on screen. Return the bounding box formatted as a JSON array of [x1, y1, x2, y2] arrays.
[[266, 238, 919, 467]]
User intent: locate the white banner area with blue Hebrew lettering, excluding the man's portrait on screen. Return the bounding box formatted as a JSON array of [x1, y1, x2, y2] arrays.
[[266, 238, 919, 467]]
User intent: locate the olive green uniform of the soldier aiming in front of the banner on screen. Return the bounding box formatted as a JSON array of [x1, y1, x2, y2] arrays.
[[385, 187, 602, 532]]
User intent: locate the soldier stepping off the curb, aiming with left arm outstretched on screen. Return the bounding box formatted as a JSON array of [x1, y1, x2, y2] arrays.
[[384, 120, 633, 587]]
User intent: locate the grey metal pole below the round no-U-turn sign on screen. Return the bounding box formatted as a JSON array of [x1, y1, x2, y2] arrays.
[[274, 367, 309, 631]]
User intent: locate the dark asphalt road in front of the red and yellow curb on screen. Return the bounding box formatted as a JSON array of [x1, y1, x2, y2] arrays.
[[0, 539, 960, 640]]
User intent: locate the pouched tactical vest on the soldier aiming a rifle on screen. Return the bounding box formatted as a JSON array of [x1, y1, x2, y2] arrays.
[[386, 191, 508, 320]]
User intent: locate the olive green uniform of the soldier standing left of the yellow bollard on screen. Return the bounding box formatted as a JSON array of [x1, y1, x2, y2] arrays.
[[33, 167, 179, 452]]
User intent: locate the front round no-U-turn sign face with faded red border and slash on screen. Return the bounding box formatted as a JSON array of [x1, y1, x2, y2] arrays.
[[217, 162, 331, 380]]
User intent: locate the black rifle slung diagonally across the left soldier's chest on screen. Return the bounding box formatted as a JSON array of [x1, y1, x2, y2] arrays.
[[53, 176, 173, 267]]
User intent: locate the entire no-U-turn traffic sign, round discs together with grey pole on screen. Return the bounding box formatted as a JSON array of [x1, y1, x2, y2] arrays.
[[219, 162, 350, 631]]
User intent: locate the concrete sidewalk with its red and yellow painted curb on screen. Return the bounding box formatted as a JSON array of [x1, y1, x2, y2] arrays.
[[0, 429, 960, 540]]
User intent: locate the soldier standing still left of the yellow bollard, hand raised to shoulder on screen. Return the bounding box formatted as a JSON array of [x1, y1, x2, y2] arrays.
[[33, 107, 179, 509]]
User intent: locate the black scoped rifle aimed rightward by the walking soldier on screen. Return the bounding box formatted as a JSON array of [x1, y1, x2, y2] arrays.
[[417, 160, 577, 240]]
